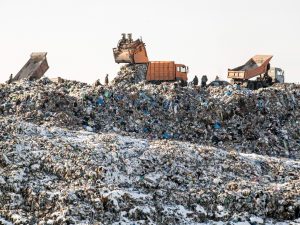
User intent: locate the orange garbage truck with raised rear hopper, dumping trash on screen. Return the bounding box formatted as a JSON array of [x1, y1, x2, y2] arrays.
[[113, 34, 188, 84]]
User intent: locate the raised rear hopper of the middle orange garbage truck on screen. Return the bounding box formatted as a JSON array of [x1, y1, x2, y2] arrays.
[[113, 34, 149, 64]]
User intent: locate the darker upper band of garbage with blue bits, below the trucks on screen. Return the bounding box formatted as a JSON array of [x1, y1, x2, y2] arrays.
[[0, 78, 300, 159]]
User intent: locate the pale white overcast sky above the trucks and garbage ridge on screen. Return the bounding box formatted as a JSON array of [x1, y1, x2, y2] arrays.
[[0, 0, 300, 83]]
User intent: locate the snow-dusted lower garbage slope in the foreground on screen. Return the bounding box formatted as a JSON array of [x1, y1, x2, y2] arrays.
[[0, 118, 300, 225]]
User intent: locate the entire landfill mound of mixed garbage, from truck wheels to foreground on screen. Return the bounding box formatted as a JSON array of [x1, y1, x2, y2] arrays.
[[0, 70, 300, 225]]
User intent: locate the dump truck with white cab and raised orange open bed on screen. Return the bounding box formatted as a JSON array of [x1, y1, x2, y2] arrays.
[[227, 55, 284, 89]]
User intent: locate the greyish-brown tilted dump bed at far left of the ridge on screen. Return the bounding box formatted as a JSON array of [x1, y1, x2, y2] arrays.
[[12, 52, 49, 81]]
